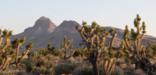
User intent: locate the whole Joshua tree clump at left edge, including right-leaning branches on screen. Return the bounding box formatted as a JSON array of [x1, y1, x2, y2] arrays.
[[0, 30, 32, 71]]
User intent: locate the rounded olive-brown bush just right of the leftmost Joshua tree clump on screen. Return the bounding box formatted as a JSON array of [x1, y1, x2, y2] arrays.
[[24, 49, 55, 75]]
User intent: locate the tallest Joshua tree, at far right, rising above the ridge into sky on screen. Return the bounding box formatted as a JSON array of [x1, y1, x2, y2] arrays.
[[123, 15, 153, 75]]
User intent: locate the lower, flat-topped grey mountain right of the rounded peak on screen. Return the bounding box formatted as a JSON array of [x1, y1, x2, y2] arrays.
[[49, 21, 81, 47]]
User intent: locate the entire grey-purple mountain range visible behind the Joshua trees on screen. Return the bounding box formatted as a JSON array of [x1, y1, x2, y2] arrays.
[[12, 16, 156, 48]]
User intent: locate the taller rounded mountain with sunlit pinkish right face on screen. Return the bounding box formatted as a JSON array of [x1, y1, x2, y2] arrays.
[[12, 16, 56, 47]]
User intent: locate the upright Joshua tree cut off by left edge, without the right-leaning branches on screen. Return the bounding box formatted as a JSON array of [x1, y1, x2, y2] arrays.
[[0, 30, 13, 70]]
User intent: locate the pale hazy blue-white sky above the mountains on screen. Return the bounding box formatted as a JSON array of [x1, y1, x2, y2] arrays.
[[0, 0, 156, 36]]
